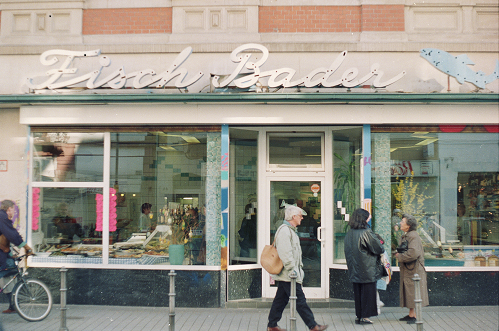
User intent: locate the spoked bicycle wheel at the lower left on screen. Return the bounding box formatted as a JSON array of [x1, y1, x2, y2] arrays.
[[12, 279, 52, 322]]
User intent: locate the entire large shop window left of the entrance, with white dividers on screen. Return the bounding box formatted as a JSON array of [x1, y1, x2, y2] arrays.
[[32, 128, 221, 265]]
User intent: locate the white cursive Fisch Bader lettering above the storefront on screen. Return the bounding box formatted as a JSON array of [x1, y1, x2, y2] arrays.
[[26, 44, 405, 90]]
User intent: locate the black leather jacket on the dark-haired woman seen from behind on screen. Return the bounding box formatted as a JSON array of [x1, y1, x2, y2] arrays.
[[345, 228, 385, 283]]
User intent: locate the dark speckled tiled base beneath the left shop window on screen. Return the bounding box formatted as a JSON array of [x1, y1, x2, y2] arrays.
[[20, 268, 222, 308]]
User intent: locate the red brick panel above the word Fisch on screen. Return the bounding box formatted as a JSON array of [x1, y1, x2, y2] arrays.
[[83, 7, 172, 35]]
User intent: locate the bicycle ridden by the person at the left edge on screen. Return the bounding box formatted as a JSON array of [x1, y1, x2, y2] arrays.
[[0, 255, 52, 322]]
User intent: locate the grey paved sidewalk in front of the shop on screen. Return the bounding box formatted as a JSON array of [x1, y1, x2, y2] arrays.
[[0, 305, 499, 331]]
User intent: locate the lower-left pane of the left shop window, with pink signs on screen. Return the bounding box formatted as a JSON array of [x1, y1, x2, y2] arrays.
[[32, 188, 102, 263]]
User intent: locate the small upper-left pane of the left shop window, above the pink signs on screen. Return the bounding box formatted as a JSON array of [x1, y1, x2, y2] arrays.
[[33, 132, 104, 182]]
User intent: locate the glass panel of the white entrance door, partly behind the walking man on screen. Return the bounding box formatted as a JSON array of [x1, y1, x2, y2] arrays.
[[270, 181, 322, 287]]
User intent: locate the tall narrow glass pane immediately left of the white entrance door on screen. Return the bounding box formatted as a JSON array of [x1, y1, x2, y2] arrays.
[[229, 129, 258, 264]]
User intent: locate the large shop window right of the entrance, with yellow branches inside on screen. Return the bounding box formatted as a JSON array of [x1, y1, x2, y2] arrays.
[[373, 127, 499, 266]]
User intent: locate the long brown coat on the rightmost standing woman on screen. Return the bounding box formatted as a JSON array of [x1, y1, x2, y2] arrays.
[[398, 231, 429, 308]]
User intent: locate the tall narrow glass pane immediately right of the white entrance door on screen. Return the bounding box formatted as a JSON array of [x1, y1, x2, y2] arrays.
[[333, 127, 362, 263]]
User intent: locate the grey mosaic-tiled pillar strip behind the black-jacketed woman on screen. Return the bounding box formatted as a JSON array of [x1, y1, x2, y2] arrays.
[[372, 133, 392, 256]]
